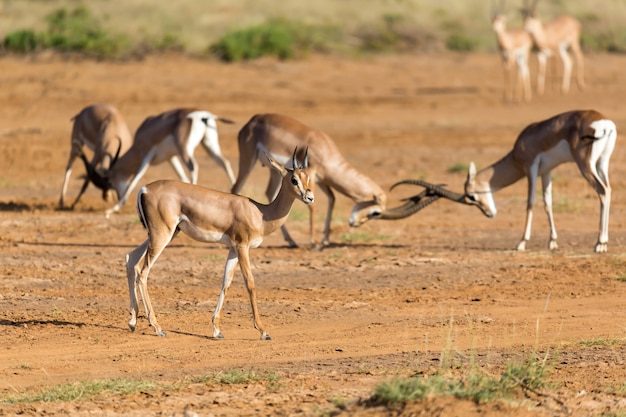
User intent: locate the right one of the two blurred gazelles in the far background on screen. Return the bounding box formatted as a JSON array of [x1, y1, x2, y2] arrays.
[[523, 0, 585, 95]]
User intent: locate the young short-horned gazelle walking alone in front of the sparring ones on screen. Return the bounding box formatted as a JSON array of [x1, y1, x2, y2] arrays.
[[126, 151, 313, 340]]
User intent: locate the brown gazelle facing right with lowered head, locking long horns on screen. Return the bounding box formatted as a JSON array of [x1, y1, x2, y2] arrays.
[[232, 114, 430, 248]]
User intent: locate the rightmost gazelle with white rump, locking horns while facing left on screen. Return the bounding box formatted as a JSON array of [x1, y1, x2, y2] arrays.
[[400, 110, 617, 252]]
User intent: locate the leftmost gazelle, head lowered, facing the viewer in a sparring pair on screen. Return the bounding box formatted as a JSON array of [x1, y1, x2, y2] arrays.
[[59, 104, 133, 209]]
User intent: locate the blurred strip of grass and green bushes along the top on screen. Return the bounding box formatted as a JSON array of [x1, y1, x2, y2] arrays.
[[0, 0, 626, 61]]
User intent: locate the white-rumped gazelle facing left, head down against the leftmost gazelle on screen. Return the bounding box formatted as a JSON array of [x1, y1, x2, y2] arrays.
[[78, 108, 235, 217]]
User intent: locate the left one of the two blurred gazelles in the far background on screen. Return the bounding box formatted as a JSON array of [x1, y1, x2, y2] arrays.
[[491, 0, 533, 102]]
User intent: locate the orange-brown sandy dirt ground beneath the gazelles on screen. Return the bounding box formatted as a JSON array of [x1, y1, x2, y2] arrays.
[[0, 50, 626, 417]]
